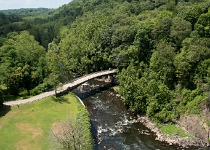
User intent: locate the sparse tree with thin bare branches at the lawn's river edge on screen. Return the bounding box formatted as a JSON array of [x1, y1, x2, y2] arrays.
[[52, 111, 92, 150]]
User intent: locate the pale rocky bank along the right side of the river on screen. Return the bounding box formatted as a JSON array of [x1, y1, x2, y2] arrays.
[[111, 87, 209, 148]]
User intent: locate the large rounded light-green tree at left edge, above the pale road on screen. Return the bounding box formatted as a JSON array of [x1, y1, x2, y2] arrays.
[[0, 31, 45, 95]]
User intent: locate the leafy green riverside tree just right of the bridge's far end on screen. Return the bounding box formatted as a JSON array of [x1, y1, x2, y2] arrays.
[[117, 63, 146, 113]]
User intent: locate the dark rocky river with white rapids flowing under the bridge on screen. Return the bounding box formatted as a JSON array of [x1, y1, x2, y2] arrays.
[[73, 80, 202, 150]]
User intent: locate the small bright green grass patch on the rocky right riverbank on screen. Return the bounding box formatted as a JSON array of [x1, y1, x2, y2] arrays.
[[160, 124, 190, 137]]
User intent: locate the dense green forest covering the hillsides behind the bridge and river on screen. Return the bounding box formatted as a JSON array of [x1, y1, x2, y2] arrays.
[[0, 0, 210, 122]]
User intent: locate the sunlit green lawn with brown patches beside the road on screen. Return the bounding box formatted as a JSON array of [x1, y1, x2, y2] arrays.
[[0, 94, 88, 150]]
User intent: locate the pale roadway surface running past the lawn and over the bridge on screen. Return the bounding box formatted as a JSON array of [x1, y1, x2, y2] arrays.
[[3, 70, 116, 106]]
